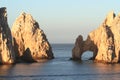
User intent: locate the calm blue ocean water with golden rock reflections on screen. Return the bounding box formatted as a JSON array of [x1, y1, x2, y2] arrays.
[[0, 44, 120, 80]]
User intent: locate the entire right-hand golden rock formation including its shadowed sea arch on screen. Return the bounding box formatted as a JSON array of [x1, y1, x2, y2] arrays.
[[72, 12, 120, 63]]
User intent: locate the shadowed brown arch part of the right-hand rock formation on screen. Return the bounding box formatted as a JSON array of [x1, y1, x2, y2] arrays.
[[72, 35, 98, 60]]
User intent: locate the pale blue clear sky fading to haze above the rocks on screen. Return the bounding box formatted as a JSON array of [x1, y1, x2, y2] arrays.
[[0, 0, 120, 43]]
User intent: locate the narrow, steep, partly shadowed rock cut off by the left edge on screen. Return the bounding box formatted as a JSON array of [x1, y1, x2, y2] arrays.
[[0, 7, 15, 64]]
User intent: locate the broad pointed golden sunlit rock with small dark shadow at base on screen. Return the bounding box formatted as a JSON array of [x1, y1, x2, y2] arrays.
[[12, 13, 54, 62]]
